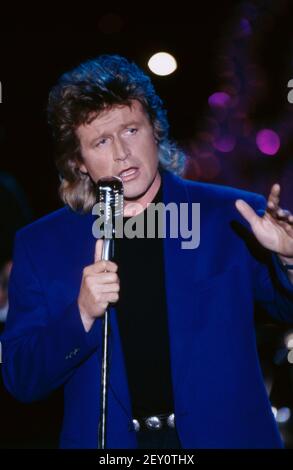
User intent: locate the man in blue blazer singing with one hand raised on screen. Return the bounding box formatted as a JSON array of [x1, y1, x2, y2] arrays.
[[3, 56, 293, 448]]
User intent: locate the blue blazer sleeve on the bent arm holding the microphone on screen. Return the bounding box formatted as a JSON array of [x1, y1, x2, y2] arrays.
[[1, 231, 101, 402]]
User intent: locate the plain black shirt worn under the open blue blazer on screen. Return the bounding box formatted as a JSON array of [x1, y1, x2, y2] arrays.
[[114, 184, 174, 417]]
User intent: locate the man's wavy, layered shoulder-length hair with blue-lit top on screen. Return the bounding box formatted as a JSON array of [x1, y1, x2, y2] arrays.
[[48, 55, 185, 213]]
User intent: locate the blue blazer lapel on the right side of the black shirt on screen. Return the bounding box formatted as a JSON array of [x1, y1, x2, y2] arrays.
[[163, 172, 199, 413]]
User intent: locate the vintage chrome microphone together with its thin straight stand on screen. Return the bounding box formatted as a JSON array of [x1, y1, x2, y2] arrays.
[[97, 176, 123, 449]]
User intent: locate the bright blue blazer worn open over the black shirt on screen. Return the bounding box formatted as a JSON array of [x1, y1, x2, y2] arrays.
[[2, 171, 293, 449]]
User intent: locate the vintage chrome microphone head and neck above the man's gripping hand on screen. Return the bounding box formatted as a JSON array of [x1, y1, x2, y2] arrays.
[[97, 176, 124, 260]]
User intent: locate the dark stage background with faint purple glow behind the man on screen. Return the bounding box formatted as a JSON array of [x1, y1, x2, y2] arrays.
[[0, 0, 293, 448]]
